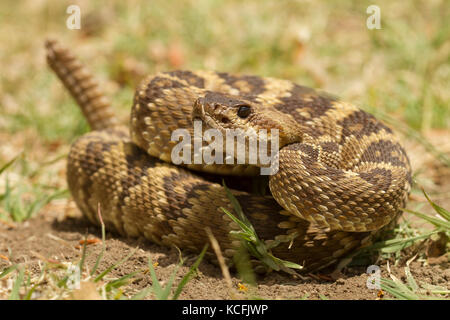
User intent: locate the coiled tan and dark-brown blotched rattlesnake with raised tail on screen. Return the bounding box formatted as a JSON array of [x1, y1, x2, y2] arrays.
[[46, 40, 411, 270]]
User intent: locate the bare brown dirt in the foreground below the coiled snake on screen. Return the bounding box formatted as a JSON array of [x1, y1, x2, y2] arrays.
[[0, 205, 450, 299]]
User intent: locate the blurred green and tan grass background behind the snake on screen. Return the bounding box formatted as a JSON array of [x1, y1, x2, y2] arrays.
[[0, 0, 450, 142]]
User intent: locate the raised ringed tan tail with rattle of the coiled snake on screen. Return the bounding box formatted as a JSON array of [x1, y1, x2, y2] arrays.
[[45, 39, 118, 130]]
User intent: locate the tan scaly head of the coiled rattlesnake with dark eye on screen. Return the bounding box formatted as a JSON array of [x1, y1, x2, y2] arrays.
[[192, 92, 302, 148]]
